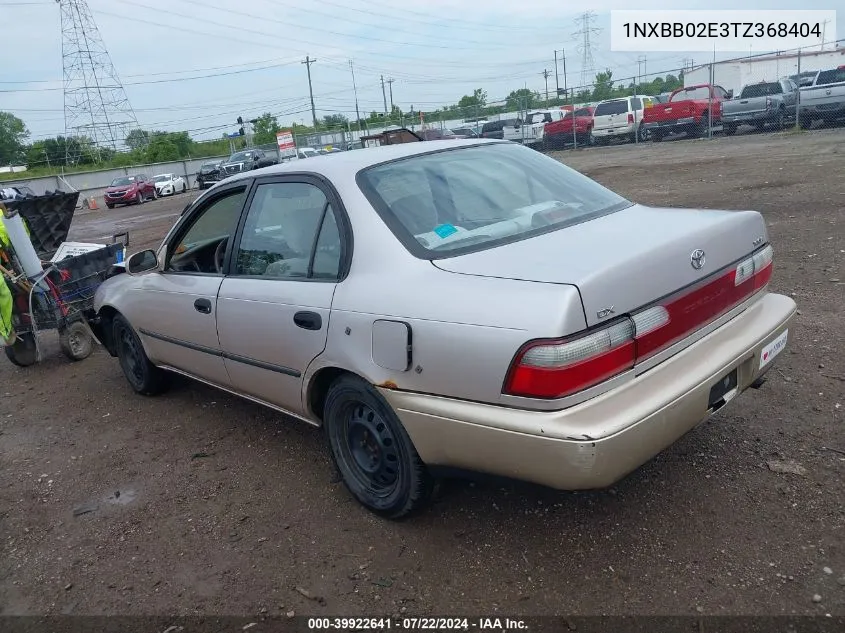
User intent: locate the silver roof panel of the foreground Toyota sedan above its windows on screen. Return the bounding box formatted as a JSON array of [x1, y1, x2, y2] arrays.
[[226, 139, 502, 182]]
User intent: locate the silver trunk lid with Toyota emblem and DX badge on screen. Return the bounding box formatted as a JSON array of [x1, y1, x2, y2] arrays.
[[433, 205, 767, 326]]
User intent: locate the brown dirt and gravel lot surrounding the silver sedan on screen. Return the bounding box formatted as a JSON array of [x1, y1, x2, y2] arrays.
[[0, 129, 845, 615]]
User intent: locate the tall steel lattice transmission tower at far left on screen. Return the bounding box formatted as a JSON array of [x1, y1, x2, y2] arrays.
[[56, 0, 138, 164]]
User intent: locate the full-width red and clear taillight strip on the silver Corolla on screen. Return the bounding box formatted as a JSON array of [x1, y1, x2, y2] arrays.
[[504, 246, 773, 398]]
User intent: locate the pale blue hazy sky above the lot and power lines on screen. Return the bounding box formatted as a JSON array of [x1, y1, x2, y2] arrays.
[[0, 0, 845, 140]]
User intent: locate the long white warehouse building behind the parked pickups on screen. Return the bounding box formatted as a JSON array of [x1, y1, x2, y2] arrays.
[[684, 46, 845, 94]]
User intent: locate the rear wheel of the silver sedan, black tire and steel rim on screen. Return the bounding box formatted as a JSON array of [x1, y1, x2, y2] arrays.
[[323, 376, 434, 519]]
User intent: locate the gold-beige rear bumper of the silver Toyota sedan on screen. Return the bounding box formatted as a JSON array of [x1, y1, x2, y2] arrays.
[[380, 294, 796, 490]]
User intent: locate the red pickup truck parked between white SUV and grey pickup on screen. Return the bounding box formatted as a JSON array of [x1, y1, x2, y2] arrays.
[[642, 84, 731, 141]]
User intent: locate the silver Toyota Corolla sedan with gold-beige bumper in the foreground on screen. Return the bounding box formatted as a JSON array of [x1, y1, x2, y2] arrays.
[[95, 140, 796, 518]]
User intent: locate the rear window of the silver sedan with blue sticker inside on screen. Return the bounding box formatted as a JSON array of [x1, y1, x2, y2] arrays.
[[358, 143, 630, 258]]
